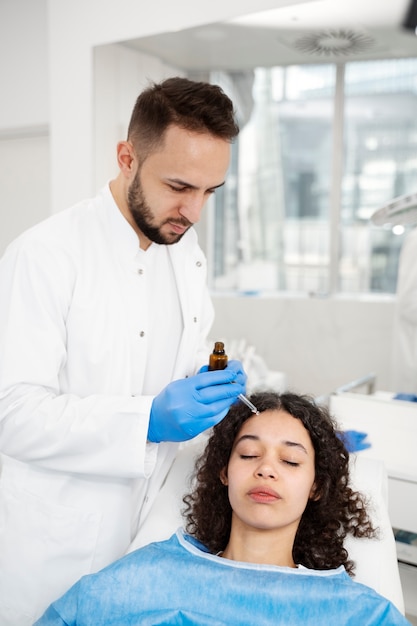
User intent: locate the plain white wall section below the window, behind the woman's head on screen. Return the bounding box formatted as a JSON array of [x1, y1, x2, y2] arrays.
[[211, 296, 394, 396]]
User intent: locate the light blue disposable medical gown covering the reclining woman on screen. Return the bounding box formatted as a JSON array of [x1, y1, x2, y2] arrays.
[[35, 531, 409, 626]]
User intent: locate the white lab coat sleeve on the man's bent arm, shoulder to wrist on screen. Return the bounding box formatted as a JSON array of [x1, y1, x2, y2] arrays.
[[0, 236, 156, 477]]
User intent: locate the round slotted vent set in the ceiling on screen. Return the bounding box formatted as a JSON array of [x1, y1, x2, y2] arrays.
[[293, 29, 374, 56]]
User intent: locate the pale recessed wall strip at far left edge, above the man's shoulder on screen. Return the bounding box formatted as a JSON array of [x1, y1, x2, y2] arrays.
[[0, 0, 51, 254]]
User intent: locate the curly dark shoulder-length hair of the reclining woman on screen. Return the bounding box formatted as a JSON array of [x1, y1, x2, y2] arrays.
[[183, 392, 376, 575]]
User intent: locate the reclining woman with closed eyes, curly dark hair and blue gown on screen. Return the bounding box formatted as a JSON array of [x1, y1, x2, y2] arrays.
[[36, 393, 408, 626]]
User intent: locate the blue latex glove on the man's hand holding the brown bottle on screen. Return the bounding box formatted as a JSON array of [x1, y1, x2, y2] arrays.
[[148, 360, 246, 443]]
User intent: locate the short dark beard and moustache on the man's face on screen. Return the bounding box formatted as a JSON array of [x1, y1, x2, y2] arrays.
[[127, 172, 192, 245]]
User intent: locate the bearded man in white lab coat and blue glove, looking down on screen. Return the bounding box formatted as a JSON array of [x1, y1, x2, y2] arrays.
[[0, 78, 246, 626]]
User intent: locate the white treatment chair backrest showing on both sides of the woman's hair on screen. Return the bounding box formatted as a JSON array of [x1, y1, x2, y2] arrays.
[[129, 435, 404, 614]]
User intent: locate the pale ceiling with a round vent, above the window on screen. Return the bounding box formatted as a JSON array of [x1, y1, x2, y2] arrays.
[[121, 0, 417, 71]]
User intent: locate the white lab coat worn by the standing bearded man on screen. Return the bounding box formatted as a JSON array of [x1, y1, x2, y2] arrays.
[[0, 187, 213, 626]]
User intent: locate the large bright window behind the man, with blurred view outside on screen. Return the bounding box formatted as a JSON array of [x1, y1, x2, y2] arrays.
[[211, 59, 417, 295]]
